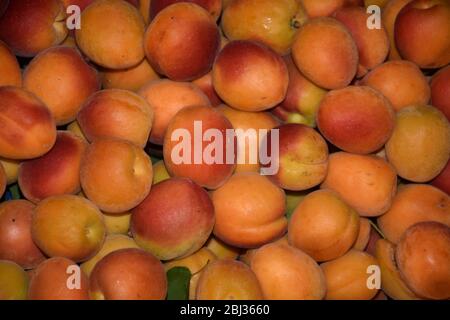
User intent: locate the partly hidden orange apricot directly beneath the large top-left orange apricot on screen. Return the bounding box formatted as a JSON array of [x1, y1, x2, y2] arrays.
[[100, 59, 159, 92]]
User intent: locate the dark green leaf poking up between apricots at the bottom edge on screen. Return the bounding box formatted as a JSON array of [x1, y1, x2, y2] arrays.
[[167, 267, 191, 300]]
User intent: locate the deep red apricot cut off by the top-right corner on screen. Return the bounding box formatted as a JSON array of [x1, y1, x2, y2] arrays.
[[394, 0, 450, 68]]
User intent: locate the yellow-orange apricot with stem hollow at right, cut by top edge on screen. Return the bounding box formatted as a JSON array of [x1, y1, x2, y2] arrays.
[[221, 0, 307, 55]]
